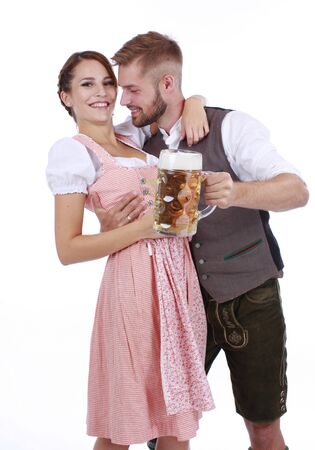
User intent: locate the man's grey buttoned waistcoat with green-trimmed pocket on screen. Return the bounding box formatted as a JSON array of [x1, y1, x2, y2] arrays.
[[144, 108, 283, 302]]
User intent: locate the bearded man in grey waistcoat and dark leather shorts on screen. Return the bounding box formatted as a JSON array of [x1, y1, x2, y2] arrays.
[[97, 32, 308, 450]]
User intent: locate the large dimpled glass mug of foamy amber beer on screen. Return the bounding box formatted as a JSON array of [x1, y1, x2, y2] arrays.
[[154, 149, 216, 237]]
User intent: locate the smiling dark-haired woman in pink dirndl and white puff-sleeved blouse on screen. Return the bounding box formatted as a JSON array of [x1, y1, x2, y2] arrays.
[[47, 52, 213, 450]]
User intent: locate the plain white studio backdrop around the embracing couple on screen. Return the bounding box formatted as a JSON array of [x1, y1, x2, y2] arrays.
[[0, 0, 315, 450]]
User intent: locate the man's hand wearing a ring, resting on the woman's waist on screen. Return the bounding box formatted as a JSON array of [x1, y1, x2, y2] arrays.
[[92, 192, 145, 232]]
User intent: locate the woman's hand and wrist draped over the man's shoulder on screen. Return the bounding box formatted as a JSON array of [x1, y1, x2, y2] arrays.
[[181, 95, 209, 147]]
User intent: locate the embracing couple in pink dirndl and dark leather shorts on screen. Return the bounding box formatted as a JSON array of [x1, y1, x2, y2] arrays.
[[47, 32, 308, 450]]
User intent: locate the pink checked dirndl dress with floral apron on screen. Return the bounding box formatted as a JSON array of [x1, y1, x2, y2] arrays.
[[74, 134, 214, 445]]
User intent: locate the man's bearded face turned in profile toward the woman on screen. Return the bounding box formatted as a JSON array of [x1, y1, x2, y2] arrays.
[[118, 62, 167, 127]]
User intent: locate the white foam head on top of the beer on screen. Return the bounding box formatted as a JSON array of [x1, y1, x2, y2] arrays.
[[158, 150, 202, 170]]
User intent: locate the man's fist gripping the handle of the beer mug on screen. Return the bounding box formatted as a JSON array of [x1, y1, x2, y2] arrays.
[[205, 172, 236, 209]]
